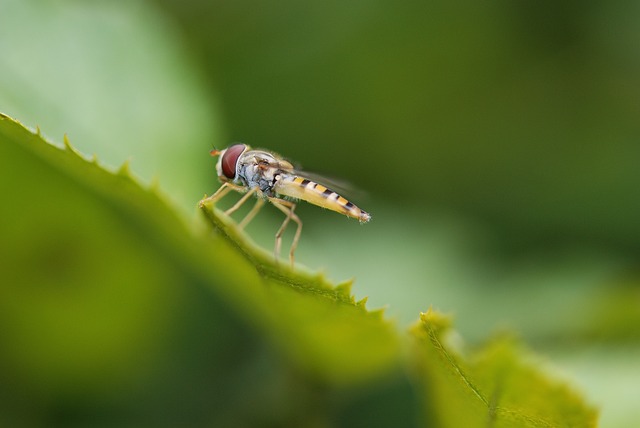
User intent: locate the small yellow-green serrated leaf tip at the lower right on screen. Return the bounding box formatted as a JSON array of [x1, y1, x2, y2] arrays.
[[414, 310, 597, 428]]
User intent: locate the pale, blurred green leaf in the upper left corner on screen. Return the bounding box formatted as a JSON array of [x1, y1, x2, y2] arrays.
[[0, 0, 221, 214]]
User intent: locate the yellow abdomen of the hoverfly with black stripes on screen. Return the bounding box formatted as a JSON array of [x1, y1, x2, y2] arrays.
[[274, 176, 371, 222]]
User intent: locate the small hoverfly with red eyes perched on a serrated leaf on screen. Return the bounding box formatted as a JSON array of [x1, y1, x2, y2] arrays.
[[200, 144, 371, 267]]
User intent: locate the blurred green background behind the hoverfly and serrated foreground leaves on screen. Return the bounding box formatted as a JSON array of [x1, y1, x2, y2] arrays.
[[0, 0, 640, 426]]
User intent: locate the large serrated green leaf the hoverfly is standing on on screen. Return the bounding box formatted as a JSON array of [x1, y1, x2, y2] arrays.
[[0, 112, 400, 421]]
